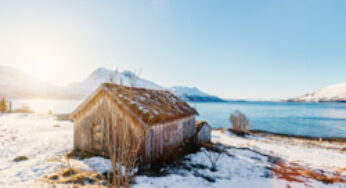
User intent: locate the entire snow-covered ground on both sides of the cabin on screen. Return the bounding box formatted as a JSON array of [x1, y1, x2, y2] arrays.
[[0, 114, 346, 188]]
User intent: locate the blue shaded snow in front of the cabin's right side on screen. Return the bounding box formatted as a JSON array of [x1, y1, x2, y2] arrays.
[[135, 149, 272, 188]]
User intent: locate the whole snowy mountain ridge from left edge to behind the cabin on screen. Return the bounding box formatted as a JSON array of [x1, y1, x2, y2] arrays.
[[0, 66, 223, 102]]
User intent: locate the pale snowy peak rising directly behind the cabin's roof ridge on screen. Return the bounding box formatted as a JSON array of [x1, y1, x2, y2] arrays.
[[64, 68, 163, 99]]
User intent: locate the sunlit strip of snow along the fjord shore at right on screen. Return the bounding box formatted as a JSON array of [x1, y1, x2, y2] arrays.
[[213, 131, 346, 175]]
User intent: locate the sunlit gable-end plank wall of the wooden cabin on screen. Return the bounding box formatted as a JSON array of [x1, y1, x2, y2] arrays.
[[74, 94, 145, 155]]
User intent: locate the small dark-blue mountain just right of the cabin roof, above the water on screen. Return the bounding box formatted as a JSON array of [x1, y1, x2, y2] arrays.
[[169, 86, 224, 102]]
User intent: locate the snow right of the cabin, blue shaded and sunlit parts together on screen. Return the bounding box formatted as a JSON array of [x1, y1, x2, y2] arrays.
[[135, 131, 346, 187]]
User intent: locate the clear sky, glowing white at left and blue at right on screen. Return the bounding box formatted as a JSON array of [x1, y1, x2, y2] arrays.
[[0, 0, 346, 98]]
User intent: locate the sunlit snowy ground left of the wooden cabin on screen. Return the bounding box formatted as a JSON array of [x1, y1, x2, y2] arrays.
[[0, 114, 73, 187]]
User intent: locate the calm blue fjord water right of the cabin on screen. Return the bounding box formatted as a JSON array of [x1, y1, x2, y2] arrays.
[[190, 102, 346, 138]]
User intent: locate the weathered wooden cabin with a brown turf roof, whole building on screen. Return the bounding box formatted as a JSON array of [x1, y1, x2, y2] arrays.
[[71, 83, 197, 163]]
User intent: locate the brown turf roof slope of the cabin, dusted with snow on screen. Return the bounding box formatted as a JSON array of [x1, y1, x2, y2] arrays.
[[103, 83, 197, 124]]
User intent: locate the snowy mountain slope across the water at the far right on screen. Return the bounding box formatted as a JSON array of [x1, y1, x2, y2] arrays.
[[289, 83, 346, 102]]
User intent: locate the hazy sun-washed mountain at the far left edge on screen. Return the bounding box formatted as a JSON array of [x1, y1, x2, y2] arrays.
[[0, 66, 62, 99]]
